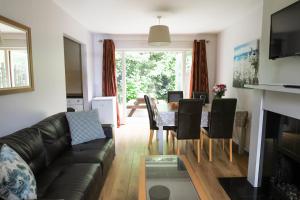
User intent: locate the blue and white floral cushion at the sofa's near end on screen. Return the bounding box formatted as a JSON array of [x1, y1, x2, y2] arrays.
[[0, 144, 37, 200]]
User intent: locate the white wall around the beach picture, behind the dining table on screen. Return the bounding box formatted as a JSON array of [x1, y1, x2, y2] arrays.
[[216, 5, 262, 150]]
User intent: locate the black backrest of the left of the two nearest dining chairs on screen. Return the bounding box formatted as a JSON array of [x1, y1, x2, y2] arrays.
[[177, 99, 203, 140]]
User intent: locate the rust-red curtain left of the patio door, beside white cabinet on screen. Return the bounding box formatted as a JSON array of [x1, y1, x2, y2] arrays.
[[102, 40, 120, 127]]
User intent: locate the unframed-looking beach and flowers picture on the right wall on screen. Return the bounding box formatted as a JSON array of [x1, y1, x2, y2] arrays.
[[233, 40, 259, 88]]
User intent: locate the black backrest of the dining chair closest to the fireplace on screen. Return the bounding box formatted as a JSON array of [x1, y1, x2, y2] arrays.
[[209, 99, 237, 138]]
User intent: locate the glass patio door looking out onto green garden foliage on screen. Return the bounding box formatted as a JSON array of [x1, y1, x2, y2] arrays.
[[116, 50, 192, 124]]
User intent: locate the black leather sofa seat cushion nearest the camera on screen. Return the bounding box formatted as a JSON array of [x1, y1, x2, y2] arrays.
[[37, 163, 103, 200]]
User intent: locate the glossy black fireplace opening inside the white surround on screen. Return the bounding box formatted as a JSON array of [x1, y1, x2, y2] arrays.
[[262, 111, 300, 200]]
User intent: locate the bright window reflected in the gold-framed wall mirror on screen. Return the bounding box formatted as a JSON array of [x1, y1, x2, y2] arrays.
[[0, 49, 29, 88]]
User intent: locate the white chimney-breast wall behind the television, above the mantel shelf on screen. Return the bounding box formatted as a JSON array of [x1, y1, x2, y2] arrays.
[[259, 0, 300, 84]]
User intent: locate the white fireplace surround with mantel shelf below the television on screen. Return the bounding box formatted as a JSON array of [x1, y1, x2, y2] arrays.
[[246, 85, 300, 187]]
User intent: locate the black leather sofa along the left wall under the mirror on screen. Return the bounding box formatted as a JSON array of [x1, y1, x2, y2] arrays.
[[0, 113, 115, 200]]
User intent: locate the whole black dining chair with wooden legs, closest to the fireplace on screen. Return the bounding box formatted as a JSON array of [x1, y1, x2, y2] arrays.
[[201, 98, 237, 162]]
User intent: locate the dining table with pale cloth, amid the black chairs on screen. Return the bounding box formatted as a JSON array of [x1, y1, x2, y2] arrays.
[[155, 101, 211, 155]]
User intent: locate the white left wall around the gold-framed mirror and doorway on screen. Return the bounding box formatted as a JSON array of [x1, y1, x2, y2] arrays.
[[0, 0, 93, 136]]
